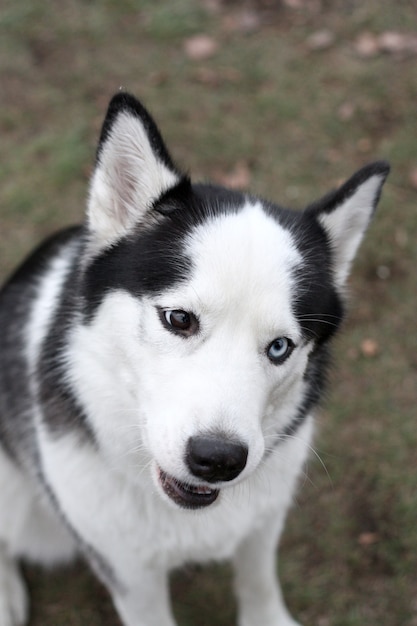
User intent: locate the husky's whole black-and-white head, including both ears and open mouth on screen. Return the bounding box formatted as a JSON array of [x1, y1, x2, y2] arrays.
[[70, 94, 388, 508]]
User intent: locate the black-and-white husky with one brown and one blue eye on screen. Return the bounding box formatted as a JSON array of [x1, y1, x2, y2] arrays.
[[0, 93, 389, 626]]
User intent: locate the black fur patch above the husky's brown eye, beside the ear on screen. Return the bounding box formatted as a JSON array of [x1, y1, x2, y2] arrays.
[[82, 178, 245, 319]]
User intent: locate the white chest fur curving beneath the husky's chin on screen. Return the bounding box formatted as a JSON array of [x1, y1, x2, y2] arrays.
[[42, 428, 303, 568]]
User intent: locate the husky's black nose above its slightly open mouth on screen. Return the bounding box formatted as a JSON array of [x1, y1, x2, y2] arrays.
[[185, 436, 248, 483]]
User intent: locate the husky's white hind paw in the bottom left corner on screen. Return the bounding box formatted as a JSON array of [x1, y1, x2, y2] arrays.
[[0, 551, 28, 626]]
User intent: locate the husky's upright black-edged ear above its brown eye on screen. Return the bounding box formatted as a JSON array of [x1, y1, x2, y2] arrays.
[[87, 93, 182, 248]]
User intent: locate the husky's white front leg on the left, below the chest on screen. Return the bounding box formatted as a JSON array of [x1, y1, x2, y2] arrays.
[[112, 569, 176, 626]]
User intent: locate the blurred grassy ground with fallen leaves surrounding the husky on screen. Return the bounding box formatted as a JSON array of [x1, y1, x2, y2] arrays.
[[0, 0, 417, 626]]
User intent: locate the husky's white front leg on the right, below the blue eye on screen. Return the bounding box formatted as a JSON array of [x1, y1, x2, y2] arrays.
[[233, 514, 300, 626]]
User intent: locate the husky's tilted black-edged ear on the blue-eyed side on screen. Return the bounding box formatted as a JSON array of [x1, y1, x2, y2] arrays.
[[306, 161, 390, 287]]
